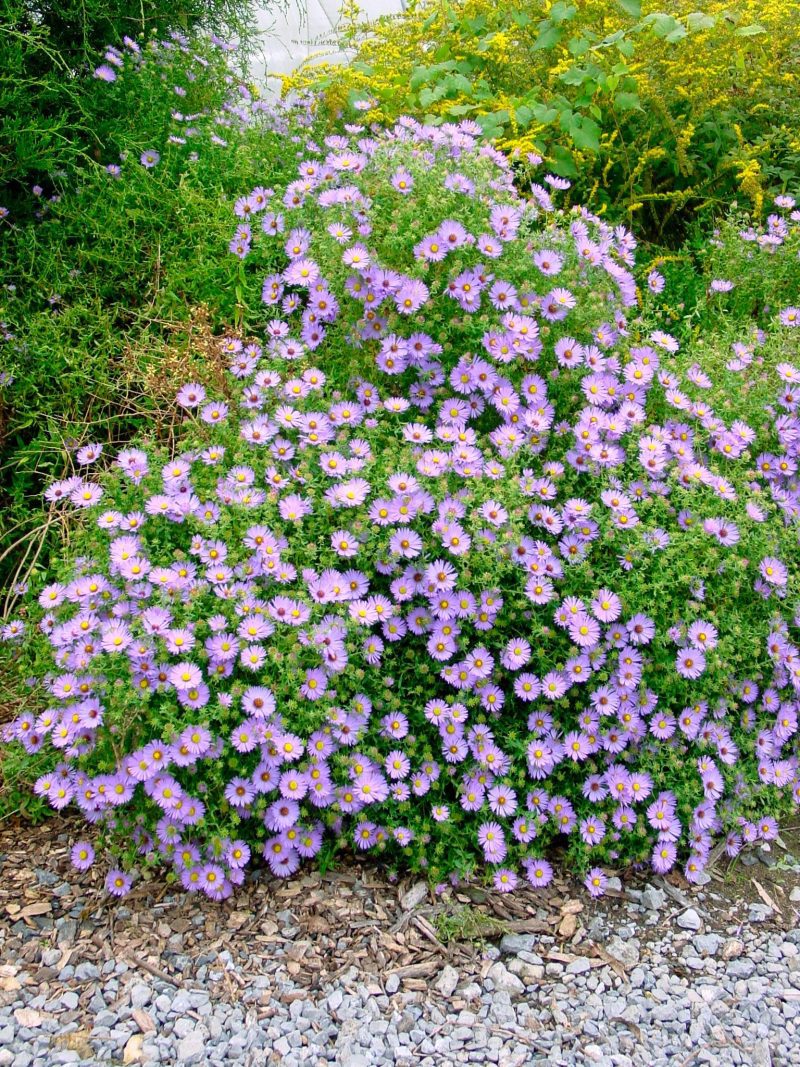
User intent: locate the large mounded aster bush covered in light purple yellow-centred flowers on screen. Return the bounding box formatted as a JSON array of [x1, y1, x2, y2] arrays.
[[3, 112, 800, 898]]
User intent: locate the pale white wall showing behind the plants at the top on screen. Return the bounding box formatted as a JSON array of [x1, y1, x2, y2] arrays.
[[254, 0, 405, 80]]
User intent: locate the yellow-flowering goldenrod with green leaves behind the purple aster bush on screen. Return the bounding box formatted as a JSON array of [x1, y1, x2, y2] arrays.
[[285, 0, 800, 239]]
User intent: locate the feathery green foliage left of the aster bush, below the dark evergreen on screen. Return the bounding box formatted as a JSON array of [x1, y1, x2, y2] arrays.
[[0, 38, 317, 586]]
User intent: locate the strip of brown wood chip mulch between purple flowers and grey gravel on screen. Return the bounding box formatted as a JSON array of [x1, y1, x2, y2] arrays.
[[0, 819, 800, 1000]]
